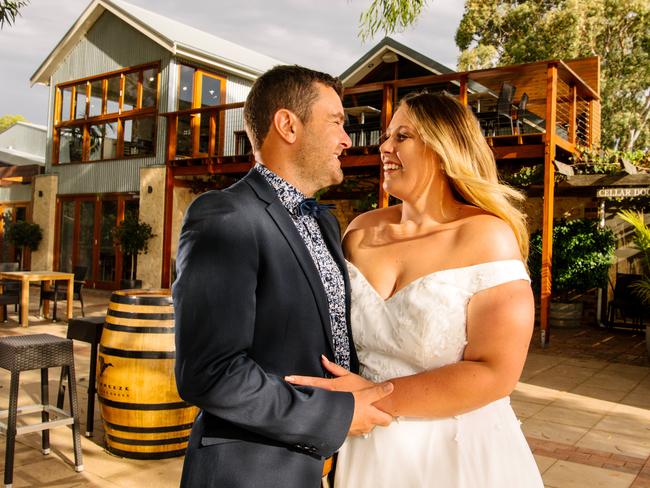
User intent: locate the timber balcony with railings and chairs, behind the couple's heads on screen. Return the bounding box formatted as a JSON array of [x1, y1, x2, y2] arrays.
[[162, 57, 600, 176]]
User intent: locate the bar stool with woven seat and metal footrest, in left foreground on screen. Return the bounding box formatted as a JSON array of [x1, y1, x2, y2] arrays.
[[0, 334, 84, 488]]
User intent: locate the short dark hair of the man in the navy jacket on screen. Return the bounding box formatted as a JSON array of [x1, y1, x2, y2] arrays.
[[244, 65, 343, 149]]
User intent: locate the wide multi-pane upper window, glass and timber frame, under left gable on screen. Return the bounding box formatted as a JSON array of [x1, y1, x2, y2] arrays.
[[53, 65, 160, 164]]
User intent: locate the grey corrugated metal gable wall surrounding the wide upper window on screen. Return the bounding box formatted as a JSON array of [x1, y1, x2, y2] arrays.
[[47, 12, 173, 195]]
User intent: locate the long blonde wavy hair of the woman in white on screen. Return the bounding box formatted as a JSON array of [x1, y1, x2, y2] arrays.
[[400, 93, 528, 261]]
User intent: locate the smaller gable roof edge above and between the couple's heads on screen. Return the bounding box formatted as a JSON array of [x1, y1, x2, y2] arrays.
[[339, 37, 454, 86]]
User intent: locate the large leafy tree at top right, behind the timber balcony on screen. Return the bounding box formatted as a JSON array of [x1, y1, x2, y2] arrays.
[[456, 0, 650, 149]]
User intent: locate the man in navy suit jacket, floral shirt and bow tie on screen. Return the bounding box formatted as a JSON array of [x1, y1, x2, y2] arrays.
[[174, 66, 392, 488]]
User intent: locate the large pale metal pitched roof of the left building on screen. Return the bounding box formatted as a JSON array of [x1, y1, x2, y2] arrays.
[[30, 0, 283, 84]]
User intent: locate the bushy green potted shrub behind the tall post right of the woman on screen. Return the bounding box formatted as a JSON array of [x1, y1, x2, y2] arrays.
[[528, 219, 616, 327]]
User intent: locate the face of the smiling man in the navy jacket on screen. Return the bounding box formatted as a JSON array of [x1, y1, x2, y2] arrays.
[[297, 83, 352, 193]]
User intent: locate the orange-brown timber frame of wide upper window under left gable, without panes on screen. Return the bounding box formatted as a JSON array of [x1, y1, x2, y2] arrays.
[[52, 62, 160, 165]]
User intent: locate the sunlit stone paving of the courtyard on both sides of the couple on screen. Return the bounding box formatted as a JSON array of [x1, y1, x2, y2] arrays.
[[0, 290, 650, 488]]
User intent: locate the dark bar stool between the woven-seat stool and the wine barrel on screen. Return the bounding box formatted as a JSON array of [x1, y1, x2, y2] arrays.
[[56, 316, 106, 437]]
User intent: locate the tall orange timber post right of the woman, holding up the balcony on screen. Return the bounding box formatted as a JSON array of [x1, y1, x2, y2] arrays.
[[540, 63, 557, 347]]
